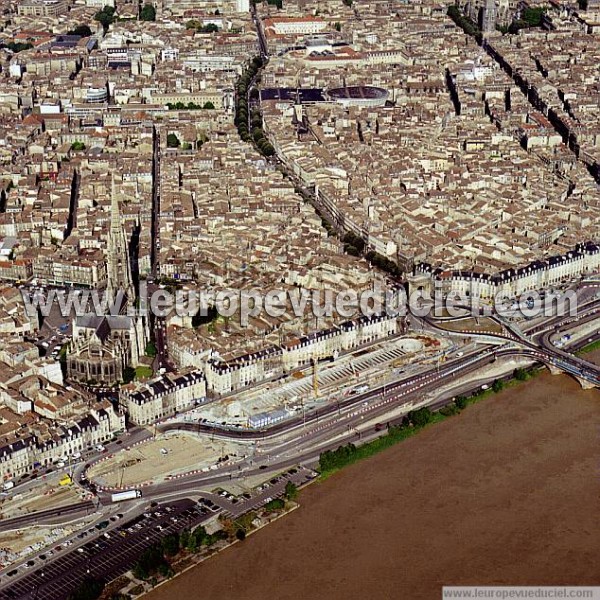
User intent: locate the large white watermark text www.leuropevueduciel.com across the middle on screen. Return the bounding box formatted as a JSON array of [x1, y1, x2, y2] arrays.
[[22, 281, 577, 326]]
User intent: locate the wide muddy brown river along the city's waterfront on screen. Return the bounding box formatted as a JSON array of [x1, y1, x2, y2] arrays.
[[148, 355, 600, 600]]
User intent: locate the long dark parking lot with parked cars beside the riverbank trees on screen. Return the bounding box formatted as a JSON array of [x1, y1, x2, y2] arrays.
[[0, 467, 316, 600]]
